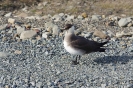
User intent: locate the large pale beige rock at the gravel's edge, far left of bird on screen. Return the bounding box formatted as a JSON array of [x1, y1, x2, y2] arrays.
[[20, 30, 37, 39]]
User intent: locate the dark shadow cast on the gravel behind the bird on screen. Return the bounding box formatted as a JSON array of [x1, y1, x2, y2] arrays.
[[93, 56, 133, 64]]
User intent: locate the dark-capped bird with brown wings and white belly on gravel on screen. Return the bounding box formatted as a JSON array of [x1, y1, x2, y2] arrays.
[[63, 24, 108, 65]]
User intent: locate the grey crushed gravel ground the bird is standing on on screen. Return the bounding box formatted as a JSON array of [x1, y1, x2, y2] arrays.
[[0, 15, 133, 88]]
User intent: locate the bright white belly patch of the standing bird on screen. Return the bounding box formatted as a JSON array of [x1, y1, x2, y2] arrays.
[[64, 41, 85, 55]]
